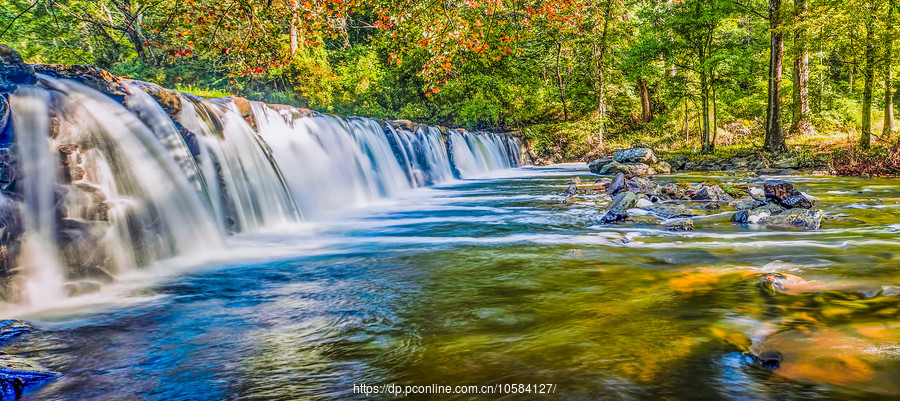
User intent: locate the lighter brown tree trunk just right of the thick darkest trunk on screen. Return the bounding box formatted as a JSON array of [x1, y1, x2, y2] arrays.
[[791, 0, 816, 135]]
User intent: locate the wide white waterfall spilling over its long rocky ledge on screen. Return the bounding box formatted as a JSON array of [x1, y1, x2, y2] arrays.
[[0, 57, 522, 305]]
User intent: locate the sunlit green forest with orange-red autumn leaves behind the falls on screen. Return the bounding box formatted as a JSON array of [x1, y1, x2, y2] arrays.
[[0, 0, 900, 168]]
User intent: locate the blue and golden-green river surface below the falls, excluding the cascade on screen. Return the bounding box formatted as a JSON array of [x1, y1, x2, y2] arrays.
[[3, 164, 900, 400]]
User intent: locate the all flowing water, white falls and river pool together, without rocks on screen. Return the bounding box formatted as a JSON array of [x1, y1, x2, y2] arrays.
[[0, 77, 900, 400]]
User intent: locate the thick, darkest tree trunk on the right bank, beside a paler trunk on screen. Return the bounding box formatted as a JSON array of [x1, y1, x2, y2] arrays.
[[765, 0, 787, 152]]
